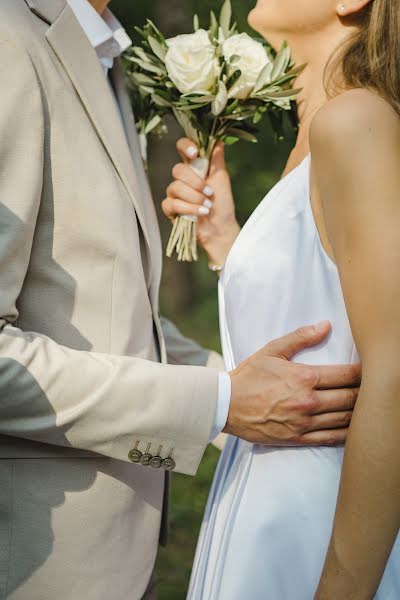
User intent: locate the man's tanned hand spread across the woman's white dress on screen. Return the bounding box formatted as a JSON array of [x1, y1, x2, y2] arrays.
[[224, 322, 361, 446]]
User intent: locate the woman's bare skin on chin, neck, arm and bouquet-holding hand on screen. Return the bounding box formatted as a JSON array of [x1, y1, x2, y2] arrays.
[[164, 0, 400, 600]]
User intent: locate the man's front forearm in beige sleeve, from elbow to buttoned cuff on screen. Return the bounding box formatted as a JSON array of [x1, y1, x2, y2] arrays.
[[0, 325, 218, 474]]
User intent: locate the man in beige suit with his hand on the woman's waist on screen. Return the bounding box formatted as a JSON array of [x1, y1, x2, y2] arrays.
[[0, 0, 358, 600]]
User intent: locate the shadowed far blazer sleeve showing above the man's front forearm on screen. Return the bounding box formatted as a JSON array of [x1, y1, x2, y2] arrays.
[[161, 317, 225, 371]]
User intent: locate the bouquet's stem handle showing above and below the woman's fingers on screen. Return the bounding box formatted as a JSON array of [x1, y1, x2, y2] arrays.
[[167, 157, 210, 262]]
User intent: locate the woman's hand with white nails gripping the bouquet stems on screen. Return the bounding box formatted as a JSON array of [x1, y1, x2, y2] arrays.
[[162, 138, 240, 265]]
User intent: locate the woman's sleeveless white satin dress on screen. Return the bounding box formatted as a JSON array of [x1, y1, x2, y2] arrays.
[[188, 156, 400, 600]]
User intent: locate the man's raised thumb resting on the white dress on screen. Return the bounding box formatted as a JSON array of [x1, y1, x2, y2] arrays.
[[264, 321, 332, 358]]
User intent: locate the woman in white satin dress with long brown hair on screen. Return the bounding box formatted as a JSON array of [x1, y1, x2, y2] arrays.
[[164, 0, 400, 600]]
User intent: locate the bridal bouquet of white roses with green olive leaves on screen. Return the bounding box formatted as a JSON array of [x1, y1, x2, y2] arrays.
[[125, 0, 302, 261]]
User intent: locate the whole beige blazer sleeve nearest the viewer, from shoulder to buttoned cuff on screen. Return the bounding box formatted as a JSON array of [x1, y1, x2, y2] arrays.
[[0, 35, 218, 474]]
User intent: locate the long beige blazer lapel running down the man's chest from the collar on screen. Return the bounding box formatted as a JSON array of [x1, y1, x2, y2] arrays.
[[26, 0, 150, 250]]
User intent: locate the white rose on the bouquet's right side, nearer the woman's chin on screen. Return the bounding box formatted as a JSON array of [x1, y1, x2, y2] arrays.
[[222, 33, 271, 100]]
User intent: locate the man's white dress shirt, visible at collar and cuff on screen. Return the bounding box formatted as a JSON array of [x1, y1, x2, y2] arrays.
[[68, 0, 232, 441]]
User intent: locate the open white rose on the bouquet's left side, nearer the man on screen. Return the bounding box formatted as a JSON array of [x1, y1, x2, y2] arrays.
[[165, 29, 220, 94]]
